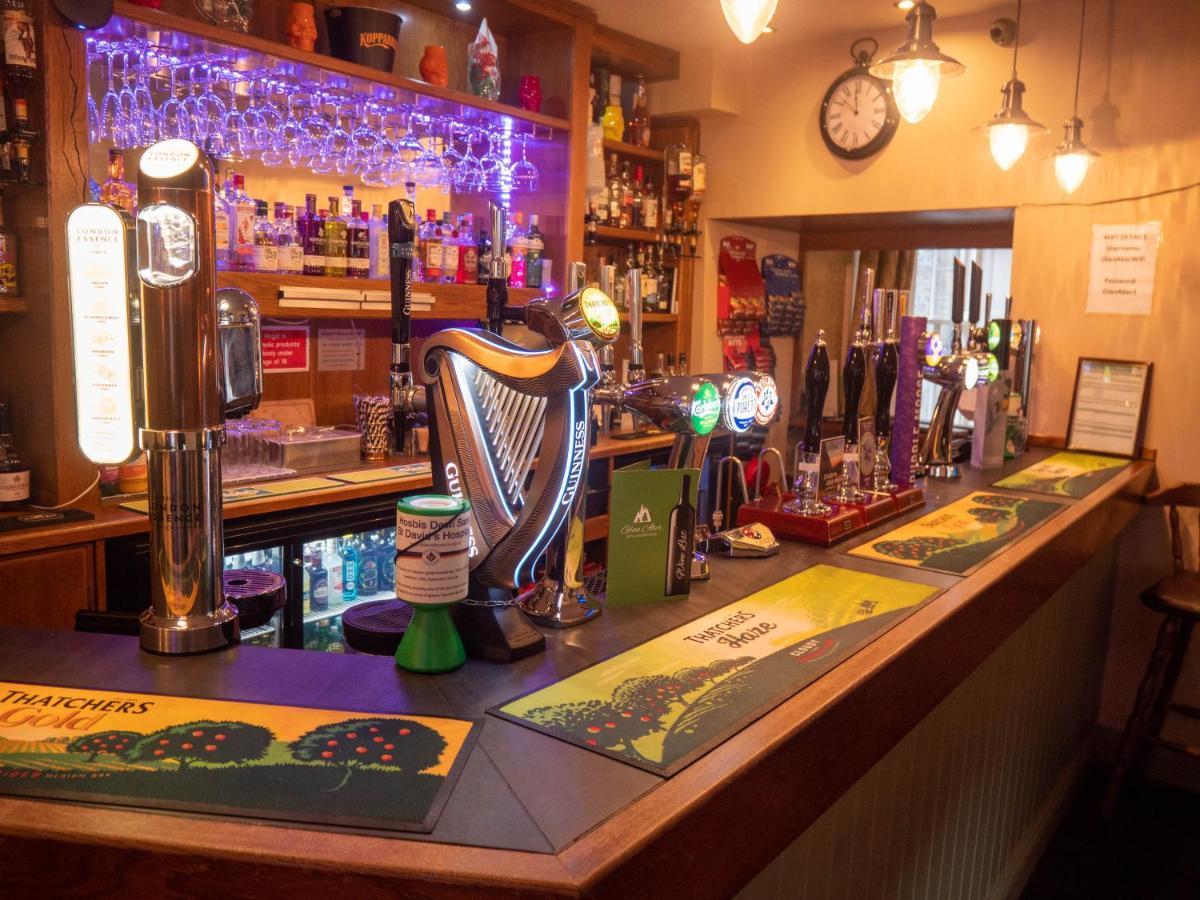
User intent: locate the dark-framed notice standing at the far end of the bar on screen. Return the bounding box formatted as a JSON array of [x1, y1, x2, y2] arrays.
[[1067, 358, 1154, 457]]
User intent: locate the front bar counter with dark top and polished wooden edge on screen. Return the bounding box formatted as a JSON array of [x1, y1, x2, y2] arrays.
[[0, 449, 1153, 898]]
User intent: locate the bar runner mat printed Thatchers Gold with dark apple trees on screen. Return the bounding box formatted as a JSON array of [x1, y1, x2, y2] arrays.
[[0, 682, 480, 832]]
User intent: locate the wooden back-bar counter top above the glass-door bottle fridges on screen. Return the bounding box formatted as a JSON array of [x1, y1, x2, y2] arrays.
[[0, 433, 674, 557]]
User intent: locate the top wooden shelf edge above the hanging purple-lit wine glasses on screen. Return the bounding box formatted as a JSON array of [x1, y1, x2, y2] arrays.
[[113, 0, 571, 133]]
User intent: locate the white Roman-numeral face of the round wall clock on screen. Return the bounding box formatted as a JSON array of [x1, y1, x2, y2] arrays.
[[821, 68, 899, 160]]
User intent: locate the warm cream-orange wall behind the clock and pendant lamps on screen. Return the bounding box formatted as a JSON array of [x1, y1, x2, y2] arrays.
[[676, 0, 1200, 739]]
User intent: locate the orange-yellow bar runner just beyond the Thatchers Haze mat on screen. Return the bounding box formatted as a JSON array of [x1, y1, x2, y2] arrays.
[[848, 493, 1063, 575]]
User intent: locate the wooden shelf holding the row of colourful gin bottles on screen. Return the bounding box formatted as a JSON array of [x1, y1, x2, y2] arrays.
[[217, 271, 541, 319]]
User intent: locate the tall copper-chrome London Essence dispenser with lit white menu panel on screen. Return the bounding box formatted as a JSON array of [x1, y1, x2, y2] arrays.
[[67, 140, 242, 654]]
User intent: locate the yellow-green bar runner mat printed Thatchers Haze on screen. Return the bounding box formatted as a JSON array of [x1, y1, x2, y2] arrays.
[[488, 565, 938, 776]]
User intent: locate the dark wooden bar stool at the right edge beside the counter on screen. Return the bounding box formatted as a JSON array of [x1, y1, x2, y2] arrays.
[[1104, 484, 1200, 814]]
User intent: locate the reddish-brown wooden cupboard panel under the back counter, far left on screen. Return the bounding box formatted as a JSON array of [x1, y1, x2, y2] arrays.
[[0, 544, 96, 630]]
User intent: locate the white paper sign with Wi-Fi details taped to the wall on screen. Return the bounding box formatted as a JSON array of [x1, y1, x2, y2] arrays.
[[1087, 222, 1163, 316]]
